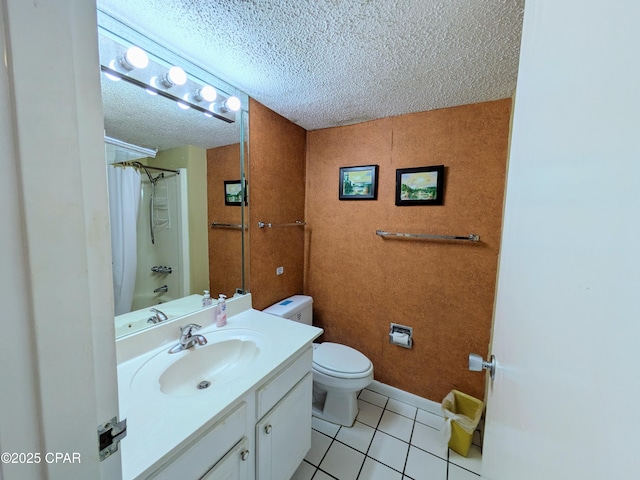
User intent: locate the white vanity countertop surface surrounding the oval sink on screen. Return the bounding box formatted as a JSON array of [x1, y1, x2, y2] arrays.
[[118, 299, 322, 479]]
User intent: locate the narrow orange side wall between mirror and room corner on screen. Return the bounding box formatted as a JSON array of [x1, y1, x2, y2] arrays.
[[248, 99, 306, 310]]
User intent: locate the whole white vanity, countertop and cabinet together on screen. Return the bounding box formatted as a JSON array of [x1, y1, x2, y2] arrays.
[[116, 295, 322, 480]]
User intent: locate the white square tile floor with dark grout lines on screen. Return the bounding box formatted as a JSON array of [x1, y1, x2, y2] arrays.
[[291, 390, 482, 480]]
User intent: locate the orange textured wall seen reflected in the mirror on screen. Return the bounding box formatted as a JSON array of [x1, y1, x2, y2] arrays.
[[207, 144, 242, 299]]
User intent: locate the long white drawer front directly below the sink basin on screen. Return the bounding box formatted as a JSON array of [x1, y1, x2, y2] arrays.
[[149, 402, 247, 480]]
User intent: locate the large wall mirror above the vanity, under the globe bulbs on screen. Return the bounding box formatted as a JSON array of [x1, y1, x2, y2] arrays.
[[98, 12, 248, 336]]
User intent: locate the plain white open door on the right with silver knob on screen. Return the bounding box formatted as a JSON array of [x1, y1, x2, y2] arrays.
[[482, 0, 640, 480]]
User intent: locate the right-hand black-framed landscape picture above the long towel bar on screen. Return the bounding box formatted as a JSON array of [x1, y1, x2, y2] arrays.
[[396, 165, 444, 206]]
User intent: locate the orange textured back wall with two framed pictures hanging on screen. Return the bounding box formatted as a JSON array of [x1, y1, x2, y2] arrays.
[[304, 99, 511, 401]]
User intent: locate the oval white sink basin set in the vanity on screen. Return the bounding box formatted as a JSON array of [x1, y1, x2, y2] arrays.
[[131, 329, 268, 397]]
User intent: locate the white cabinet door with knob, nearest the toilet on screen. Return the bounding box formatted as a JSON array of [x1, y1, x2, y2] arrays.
[[256, 373, 313, 480]]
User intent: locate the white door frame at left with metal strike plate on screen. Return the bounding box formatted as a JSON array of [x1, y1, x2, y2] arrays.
[[0, 0, 121, 480]]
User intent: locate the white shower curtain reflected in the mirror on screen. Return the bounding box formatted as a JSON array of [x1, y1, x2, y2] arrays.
[[108, 165, 141, 315]]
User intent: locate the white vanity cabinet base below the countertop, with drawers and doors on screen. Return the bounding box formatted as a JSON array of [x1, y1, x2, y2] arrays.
[[147, 345, 313, 480]]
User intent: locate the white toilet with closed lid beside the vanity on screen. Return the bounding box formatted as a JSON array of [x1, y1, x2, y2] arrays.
[[264, 295, 373, 427]]
